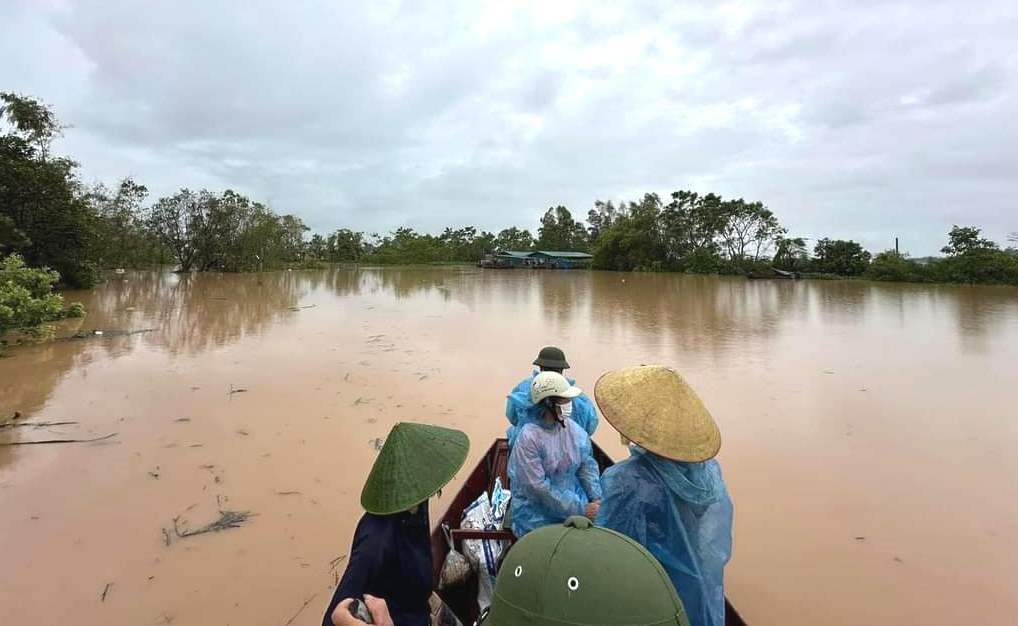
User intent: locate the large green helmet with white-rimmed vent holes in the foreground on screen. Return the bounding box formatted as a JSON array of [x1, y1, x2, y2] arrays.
[[484, 516, 689, 626]]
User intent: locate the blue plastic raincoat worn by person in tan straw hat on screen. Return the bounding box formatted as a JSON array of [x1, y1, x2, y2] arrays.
[[597, 446, 733, 626]]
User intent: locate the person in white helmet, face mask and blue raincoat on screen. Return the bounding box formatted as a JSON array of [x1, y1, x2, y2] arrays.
[[509, 372, 601, 537]]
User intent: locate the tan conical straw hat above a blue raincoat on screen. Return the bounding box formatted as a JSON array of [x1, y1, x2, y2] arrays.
[[593, 365, 721, 463]]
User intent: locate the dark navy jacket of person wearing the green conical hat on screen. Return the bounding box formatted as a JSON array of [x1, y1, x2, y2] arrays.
[[322, 502, 434, 626]]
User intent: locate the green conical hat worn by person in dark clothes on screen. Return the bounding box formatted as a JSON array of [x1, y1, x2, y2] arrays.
[[360, 422, 470, 515]]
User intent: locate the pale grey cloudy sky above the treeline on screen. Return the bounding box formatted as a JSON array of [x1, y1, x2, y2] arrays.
[[0, 0, 1018, 254]]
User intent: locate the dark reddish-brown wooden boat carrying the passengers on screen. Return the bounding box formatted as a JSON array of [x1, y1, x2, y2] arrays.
[[432, 439, 746, 626]]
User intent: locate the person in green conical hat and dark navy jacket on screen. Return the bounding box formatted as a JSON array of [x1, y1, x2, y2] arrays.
[[322, 422, 470, 626]]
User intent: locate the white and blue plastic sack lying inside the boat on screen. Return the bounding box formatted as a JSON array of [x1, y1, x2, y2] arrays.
[[459, 478, 512, 611]]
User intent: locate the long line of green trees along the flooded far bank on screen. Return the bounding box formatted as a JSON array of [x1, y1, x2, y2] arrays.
[[0, 88, 1018, 325]]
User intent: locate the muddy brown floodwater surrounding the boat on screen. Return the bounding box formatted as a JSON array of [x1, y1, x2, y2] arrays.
[[0, 269, 1018, 626]]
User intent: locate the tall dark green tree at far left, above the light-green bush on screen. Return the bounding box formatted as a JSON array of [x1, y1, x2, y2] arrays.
[[0, 93, 96, 287]]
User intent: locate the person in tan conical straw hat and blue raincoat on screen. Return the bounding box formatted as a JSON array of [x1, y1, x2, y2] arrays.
[[593, 366, 733, 626]]
